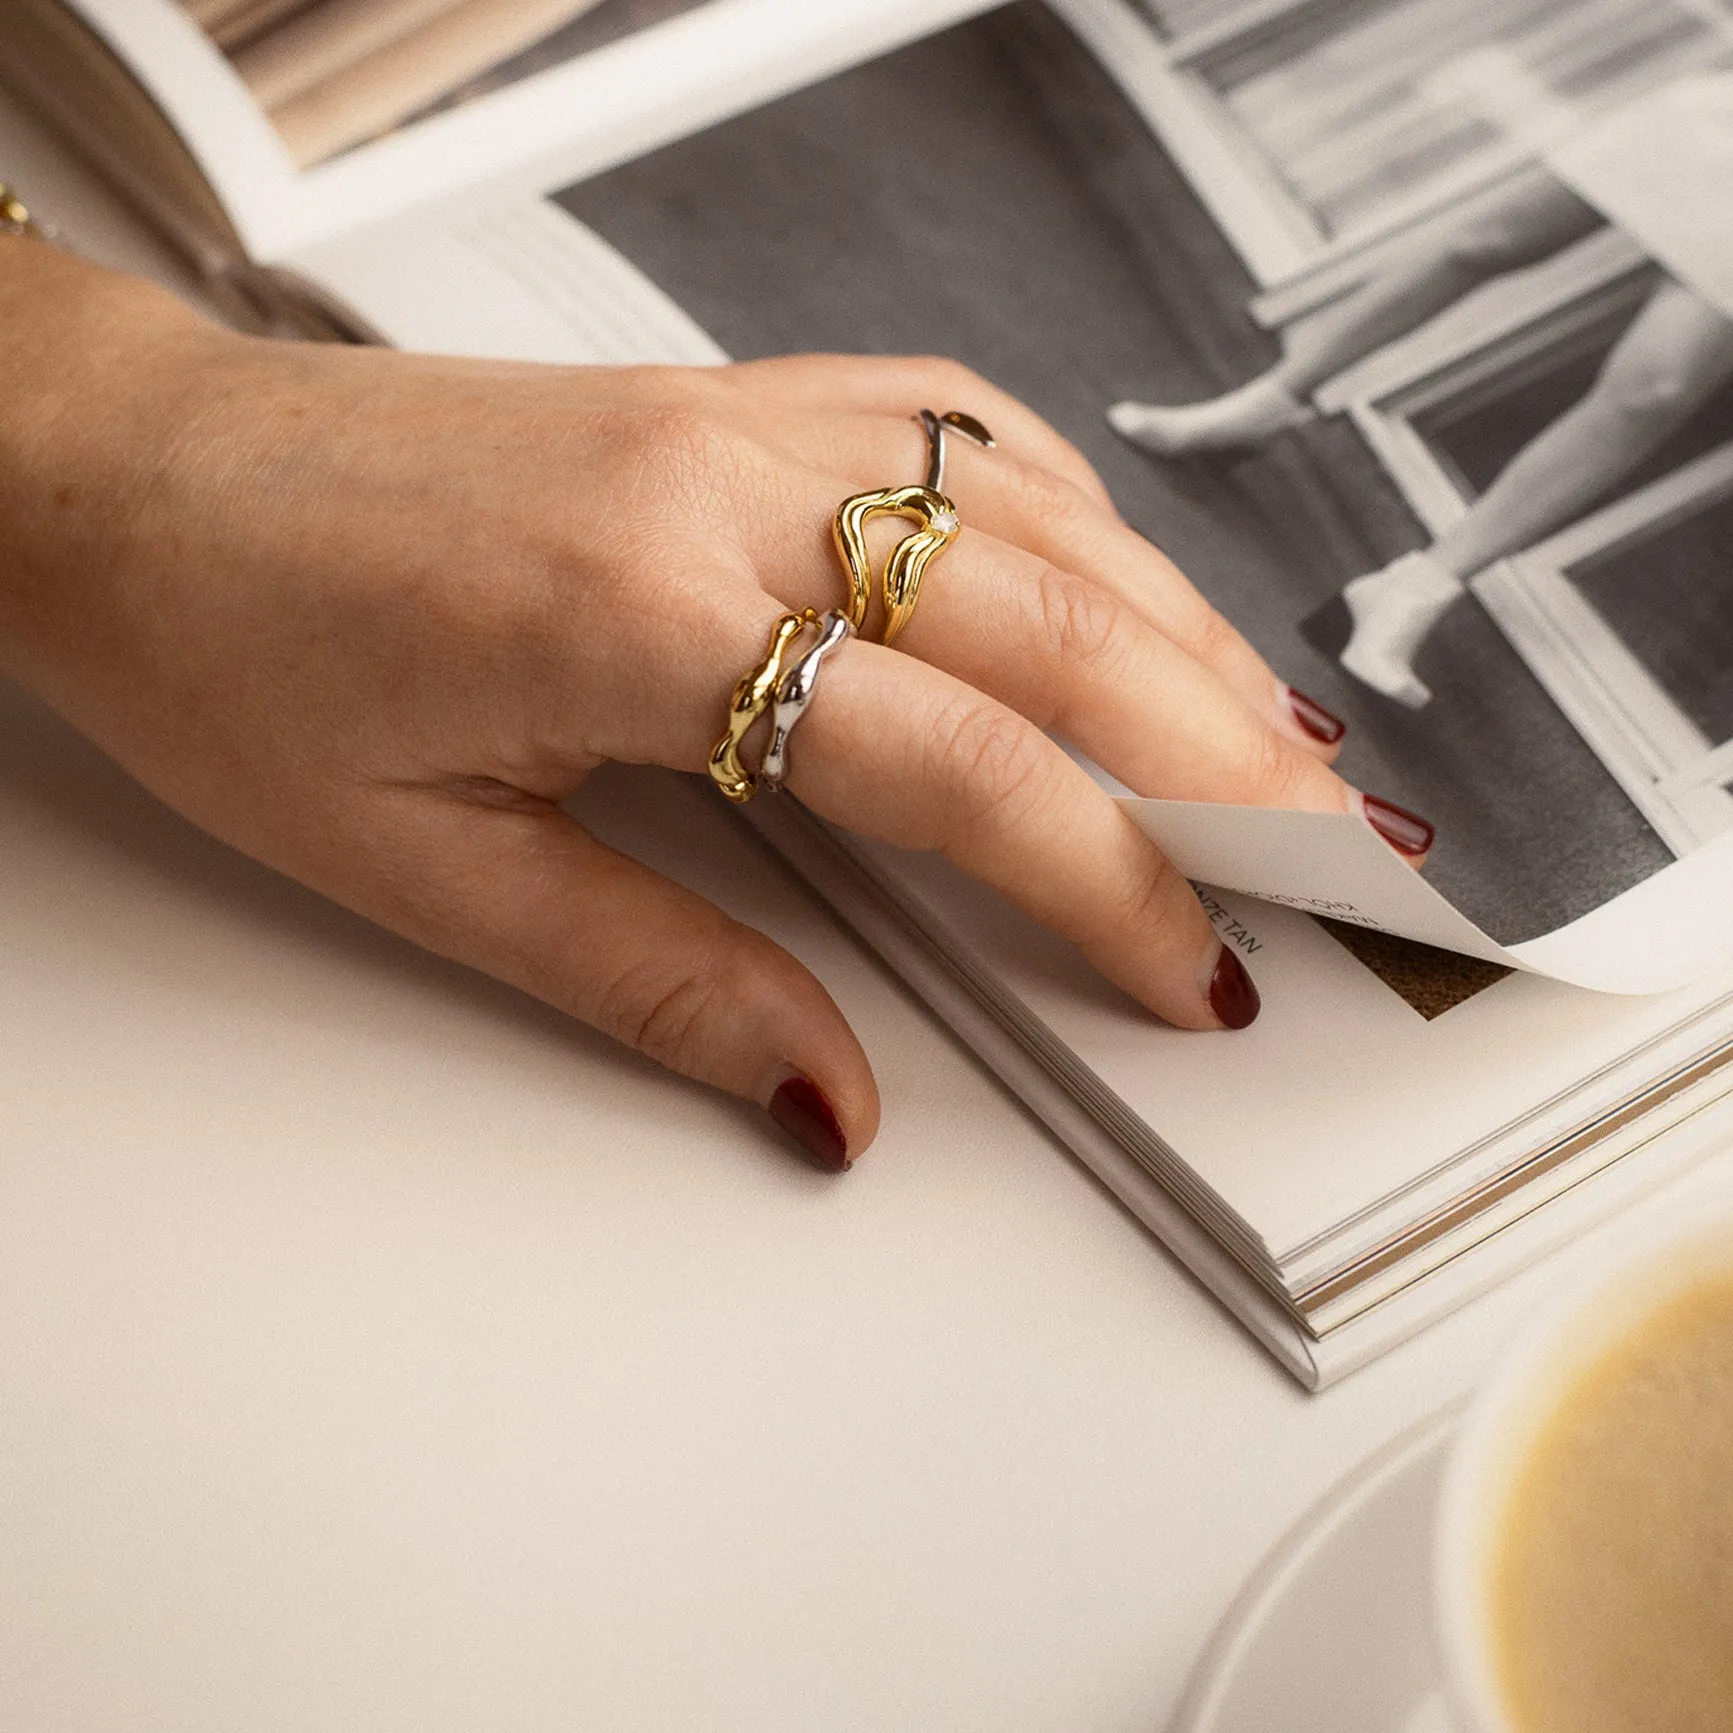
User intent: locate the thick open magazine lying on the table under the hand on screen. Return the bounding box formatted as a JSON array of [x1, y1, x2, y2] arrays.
[[13, 0, 1733, 1386]]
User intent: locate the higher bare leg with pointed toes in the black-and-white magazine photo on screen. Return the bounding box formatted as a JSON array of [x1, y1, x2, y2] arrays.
[[1107, 165, 1601, 458]]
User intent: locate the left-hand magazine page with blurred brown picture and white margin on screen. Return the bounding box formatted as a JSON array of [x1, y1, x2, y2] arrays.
[[61, 0, 990, 263]]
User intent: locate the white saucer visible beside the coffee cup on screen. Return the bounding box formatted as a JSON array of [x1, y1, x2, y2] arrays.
[[1168, 1407, 1461, 1733]]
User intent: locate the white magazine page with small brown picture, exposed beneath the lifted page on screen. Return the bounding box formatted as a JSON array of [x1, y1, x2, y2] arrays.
[[860, 844, 1733, 1291]]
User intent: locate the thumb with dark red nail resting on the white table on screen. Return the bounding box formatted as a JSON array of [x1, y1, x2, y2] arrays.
[[344, 789, 879, 1172]]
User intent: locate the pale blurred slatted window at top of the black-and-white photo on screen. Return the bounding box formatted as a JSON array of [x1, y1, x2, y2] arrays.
[[1122, 0, 1733, 294]]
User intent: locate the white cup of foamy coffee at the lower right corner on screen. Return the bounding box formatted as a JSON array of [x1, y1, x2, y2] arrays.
[[1435, 1213, 1733, 1733]]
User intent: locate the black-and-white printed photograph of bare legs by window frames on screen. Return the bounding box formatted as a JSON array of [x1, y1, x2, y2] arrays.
[[556, 0, 1733, 943]]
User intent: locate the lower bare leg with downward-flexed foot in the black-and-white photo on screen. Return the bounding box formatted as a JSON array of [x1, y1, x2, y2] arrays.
[[1317, 279, 1733, 709]]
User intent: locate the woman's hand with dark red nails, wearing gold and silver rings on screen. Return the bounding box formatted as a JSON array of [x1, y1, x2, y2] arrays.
[[0, 243, 1379, 1166]]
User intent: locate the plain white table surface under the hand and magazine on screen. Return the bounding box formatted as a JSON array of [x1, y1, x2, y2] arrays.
[[0, 91, 1733, 1733]]
